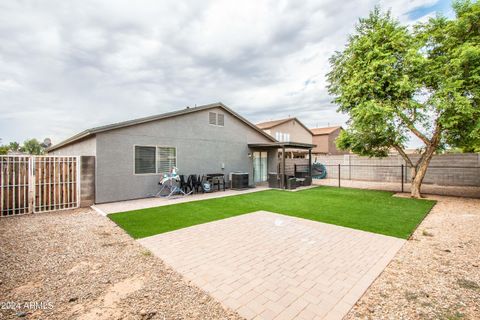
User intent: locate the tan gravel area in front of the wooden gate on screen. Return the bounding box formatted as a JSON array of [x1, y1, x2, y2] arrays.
[[0, 209, 239, 319]]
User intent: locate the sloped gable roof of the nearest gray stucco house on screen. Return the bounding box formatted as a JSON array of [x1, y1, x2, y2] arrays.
[[47, 102, 277, 151]]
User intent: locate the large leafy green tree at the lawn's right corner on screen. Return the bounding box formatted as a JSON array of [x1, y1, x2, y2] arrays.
[[327, 1, 480, 198]]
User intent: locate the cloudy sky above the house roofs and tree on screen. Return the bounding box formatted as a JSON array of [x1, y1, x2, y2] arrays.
[[0, 0, 451, 148]]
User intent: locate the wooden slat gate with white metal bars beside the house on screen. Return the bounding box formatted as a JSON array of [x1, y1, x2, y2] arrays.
[[0, 156, 80, 217]]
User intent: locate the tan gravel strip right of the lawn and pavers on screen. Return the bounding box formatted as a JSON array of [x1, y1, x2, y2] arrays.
[[346, 196, 480, 320]]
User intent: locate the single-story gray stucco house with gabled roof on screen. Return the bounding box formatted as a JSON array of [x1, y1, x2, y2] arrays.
[[47, 103, 278, 203]]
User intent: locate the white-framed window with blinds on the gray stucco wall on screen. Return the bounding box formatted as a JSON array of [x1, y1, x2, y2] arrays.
[[135, 146, 177, 174]]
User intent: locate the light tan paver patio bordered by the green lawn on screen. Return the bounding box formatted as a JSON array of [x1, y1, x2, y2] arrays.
[[138, 211, 405, 319]]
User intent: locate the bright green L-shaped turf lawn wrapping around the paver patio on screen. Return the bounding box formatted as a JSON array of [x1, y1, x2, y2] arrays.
[[109, 187, 435, 239]]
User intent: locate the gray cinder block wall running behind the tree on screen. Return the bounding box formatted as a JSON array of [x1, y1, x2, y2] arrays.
[[286, 153, 480, 186]]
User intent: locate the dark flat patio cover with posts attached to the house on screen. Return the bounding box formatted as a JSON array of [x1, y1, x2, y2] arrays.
[[248, 142, 316, 189]]
